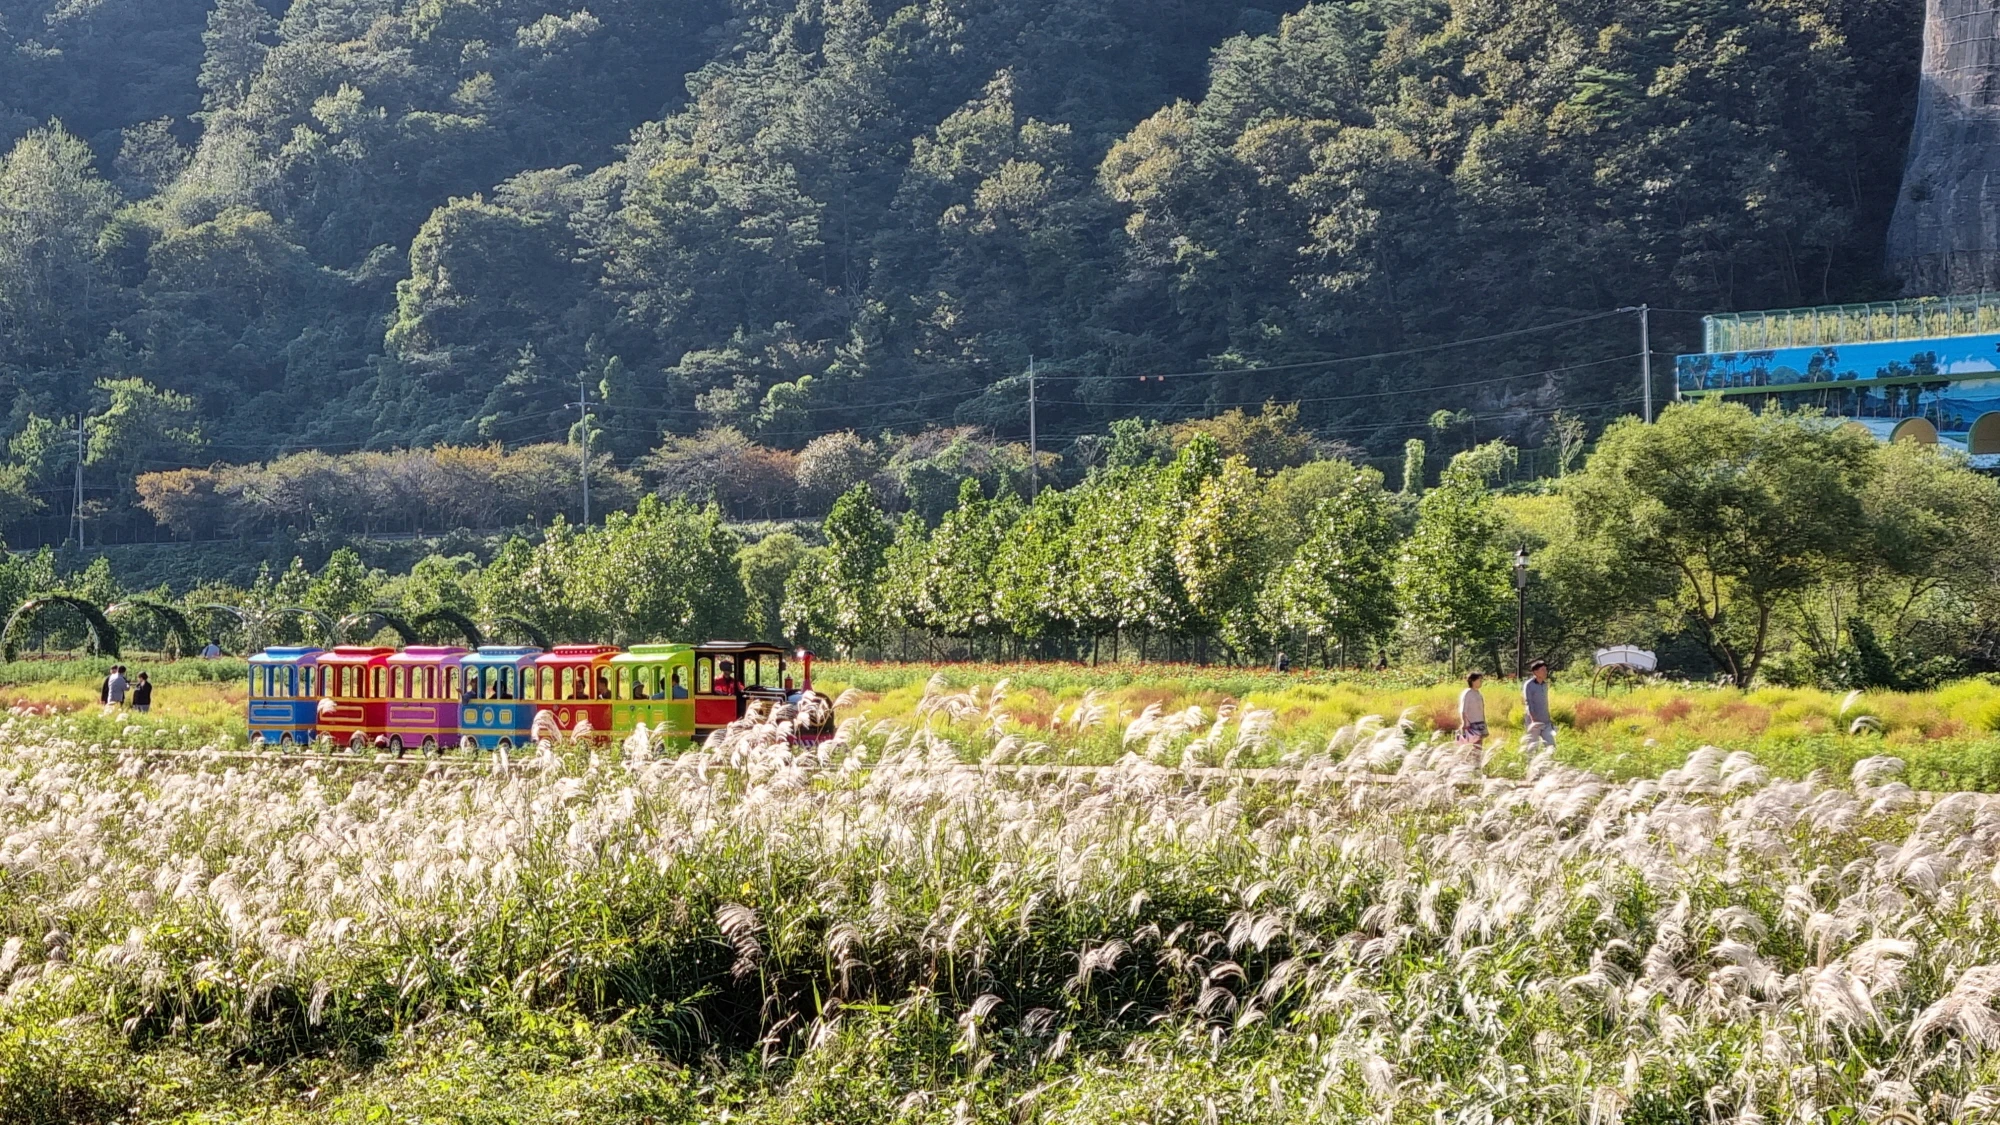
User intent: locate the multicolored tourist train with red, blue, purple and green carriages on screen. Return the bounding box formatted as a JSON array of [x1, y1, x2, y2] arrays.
[[246, 641, 834, 755]]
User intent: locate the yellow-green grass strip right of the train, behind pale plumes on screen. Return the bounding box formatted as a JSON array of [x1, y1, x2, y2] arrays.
[[816, 663, 2000, 793]]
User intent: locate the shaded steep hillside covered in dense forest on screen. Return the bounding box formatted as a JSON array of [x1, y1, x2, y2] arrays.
[[0, 0, 1922, 538]]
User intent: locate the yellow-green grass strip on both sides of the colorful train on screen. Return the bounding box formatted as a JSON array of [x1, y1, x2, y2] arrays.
[[11, 657, 2000, 793]]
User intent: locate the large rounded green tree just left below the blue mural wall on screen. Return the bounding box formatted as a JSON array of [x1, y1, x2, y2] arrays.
[[1570, 402, 1874, 689]]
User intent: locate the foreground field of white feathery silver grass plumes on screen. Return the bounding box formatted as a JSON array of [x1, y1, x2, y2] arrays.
[[0, 685, 2000, 1125]]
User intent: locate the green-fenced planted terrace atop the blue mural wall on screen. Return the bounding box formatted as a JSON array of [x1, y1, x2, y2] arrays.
[[1702, 292, 2000, 354]]
